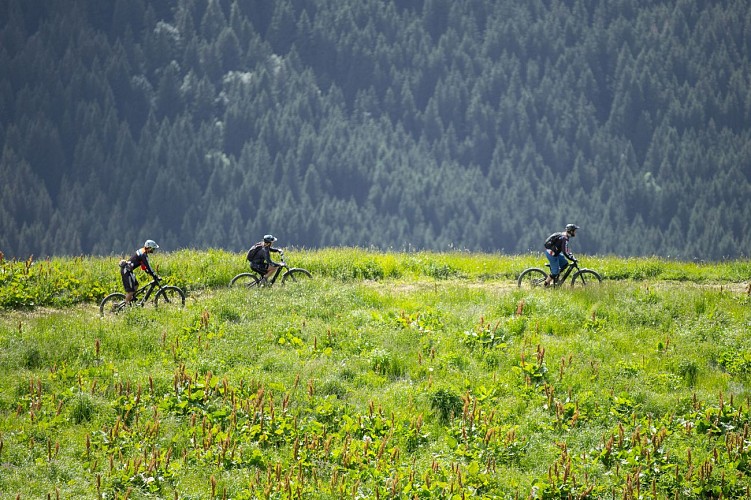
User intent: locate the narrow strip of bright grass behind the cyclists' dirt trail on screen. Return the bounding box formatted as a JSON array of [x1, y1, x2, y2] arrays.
[[0, 248, 751, 309]]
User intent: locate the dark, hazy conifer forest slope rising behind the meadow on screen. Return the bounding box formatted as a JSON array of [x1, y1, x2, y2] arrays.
[[0, 0, 751, 260]]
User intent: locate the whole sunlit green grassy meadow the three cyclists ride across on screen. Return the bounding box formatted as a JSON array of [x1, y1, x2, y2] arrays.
[[0, 252, 751, 499]]
